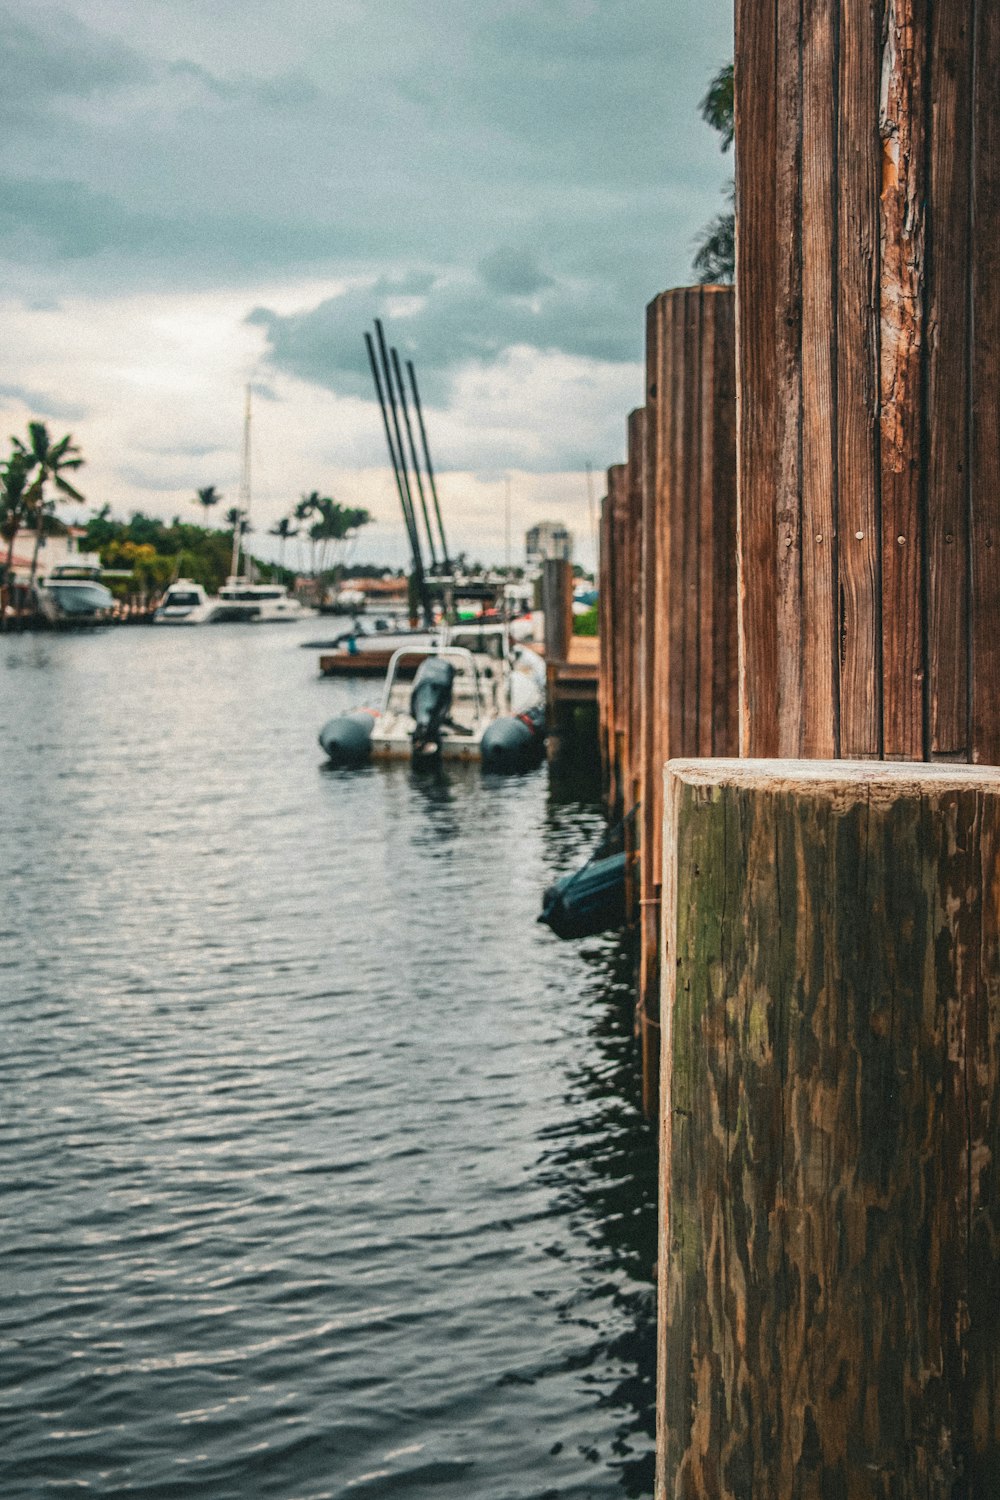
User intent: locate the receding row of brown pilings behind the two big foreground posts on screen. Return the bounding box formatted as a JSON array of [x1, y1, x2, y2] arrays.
[[600, 287, 738, 1113]]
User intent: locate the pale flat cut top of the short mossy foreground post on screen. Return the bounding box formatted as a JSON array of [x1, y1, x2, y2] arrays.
[[664, 758, 1000, 798]]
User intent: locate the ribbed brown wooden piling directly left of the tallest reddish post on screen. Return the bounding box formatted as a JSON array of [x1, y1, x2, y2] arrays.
[[630, 287, 738, 1115]]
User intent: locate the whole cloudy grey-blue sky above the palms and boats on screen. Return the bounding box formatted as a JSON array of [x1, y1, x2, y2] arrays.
[[0, 0, 732, 563]]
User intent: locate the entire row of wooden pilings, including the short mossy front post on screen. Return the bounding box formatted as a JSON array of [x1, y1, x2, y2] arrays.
[[600, 0, 1000, 1500]]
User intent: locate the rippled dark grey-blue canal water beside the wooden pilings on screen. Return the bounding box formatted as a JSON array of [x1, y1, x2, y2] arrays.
[[0, 623, 655, 1500]]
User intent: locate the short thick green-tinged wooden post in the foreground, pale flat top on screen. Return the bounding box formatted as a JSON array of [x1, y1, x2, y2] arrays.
[[657, 761, 1000, 1500]]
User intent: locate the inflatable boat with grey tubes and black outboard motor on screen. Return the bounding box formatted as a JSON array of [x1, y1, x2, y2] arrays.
[[319, 626, 546, 771]]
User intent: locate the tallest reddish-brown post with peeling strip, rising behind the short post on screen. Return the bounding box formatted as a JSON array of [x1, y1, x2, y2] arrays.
[[736, 0, 1000, 764]]
